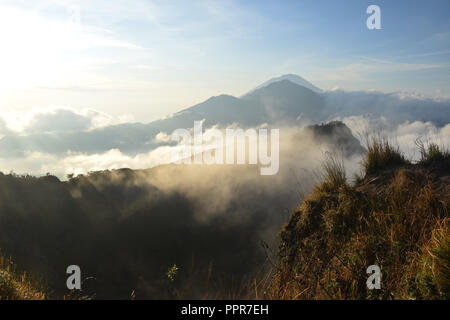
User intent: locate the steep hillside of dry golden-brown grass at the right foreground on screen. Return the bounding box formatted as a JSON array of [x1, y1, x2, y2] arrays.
[[269, 140, 450, 299]]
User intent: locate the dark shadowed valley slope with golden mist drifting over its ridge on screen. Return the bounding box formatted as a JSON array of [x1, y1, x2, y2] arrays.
[[0, 123, 364, 299]]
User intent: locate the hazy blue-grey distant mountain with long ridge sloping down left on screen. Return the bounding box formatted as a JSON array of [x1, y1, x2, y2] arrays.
[[0, 80, 323, 157]]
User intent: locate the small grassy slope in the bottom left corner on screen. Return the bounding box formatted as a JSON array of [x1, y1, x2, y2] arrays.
[[0, 255, 46, 300]]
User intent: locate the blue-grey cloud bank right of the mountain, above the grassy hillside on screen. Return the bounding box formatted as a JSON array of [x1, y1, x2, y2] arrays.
[[325, 90, 450, 161]]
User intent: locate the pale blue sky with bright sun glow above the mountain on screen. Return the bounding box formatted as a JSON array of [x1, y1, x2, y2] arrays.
[[0, 0, 450, 125]]
